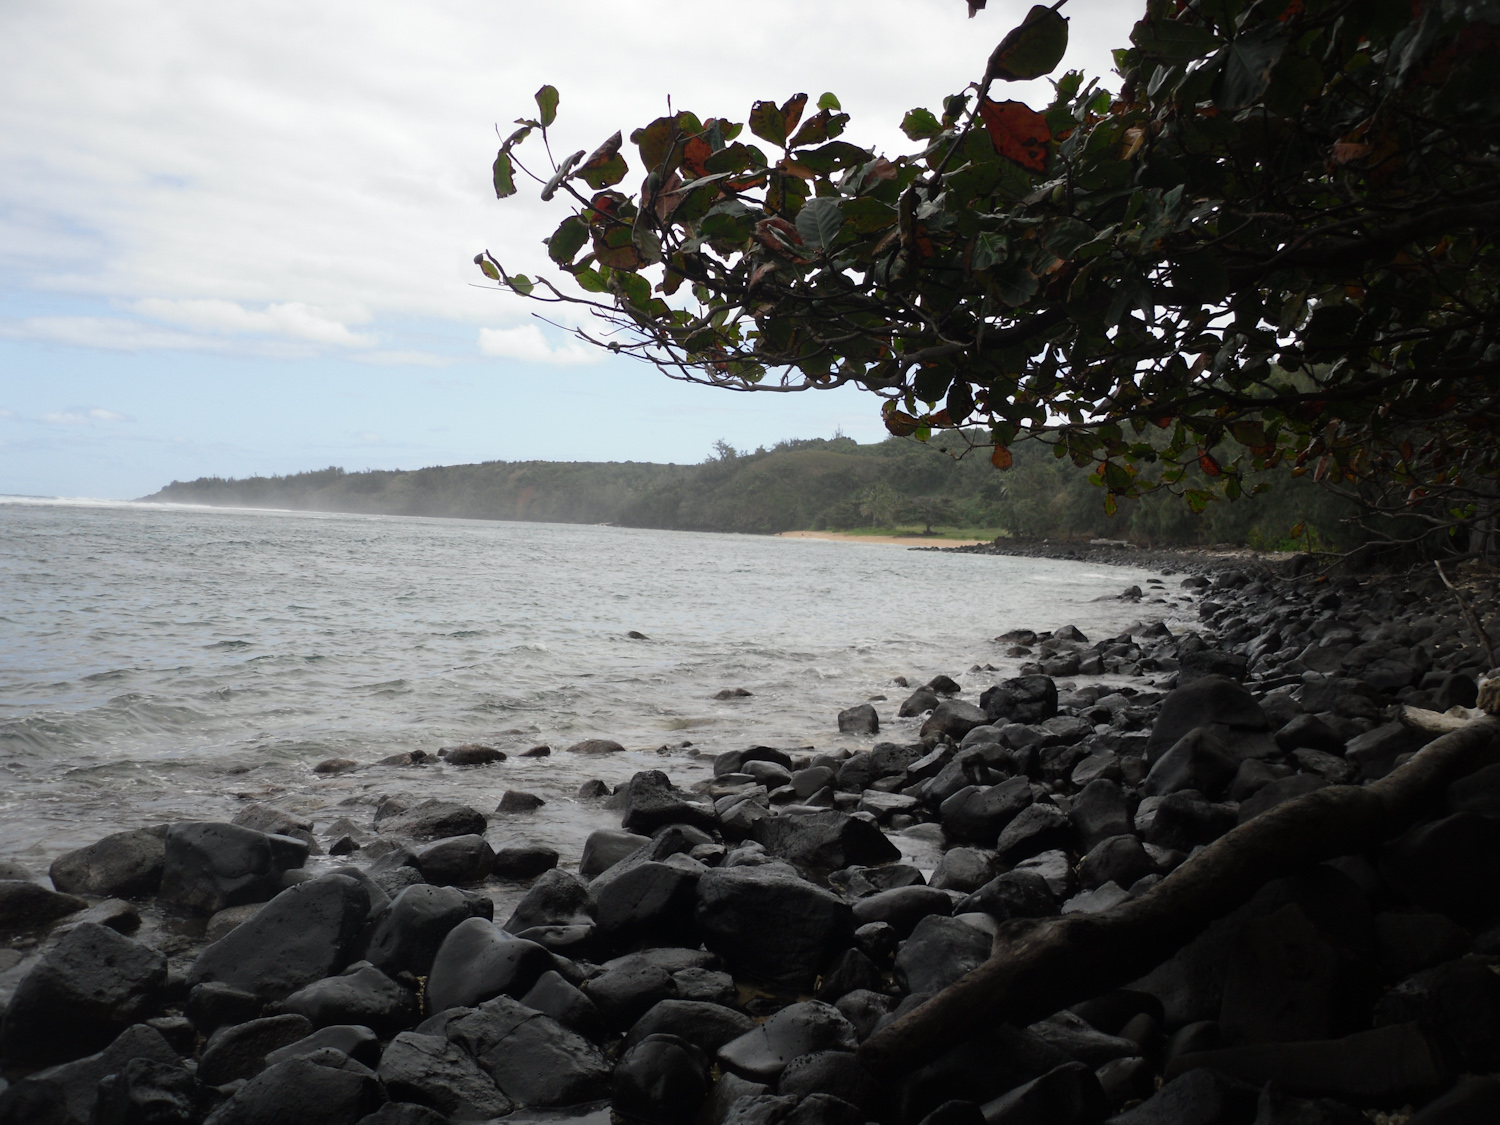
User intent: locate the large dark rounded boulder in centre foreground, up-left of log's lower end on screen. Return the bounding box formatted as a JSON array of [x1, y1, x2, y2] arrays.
[[698, 866, 854, 989]]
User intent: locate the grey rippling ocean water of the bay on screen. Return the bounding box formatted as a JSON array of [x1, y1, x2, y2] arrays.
[[0, 498, 1187, 872]]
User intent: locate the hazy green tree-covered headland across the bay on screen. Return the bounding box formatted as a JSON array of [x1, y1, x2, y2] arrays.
[[146, 434, 1361, 549]]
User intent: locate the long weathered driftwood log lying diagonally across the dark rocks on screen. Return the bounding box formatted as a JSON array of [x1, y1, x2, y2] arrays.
[[860, 680, 1500, 1074]]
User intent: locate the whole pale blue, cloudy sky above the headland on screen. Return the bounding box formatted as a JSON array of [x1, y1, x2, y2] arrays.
[[0, 0, 1142, 500]]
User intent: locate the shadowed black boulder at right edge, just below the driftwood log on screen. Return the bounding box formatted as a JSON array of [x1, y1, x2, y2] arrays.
[[1380, 813, 1500, 924]]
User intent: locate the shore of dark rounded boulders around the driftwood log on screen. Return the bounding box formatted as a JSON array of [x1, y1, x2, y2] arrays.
[[0, 561, 1500, 1125]]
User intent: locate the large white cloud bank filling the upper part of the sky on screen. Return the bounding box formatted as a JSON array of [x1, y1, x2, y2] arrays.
[[0, 0, 1140, 363]]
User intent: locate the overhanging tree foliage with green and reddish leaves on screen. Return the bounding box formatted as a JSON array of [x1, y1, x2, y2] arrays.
[[476, 0, 1500, 555]]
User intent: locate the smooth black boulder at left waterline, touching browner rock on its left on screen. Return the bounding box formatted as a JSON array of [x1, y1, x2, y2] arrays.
[[159, 821, 308, 914]]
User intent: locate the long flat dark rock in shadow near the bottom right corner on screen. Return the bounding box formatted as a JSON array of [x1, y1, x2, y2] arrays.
[[1167, 1023, 1452, 1103]]
